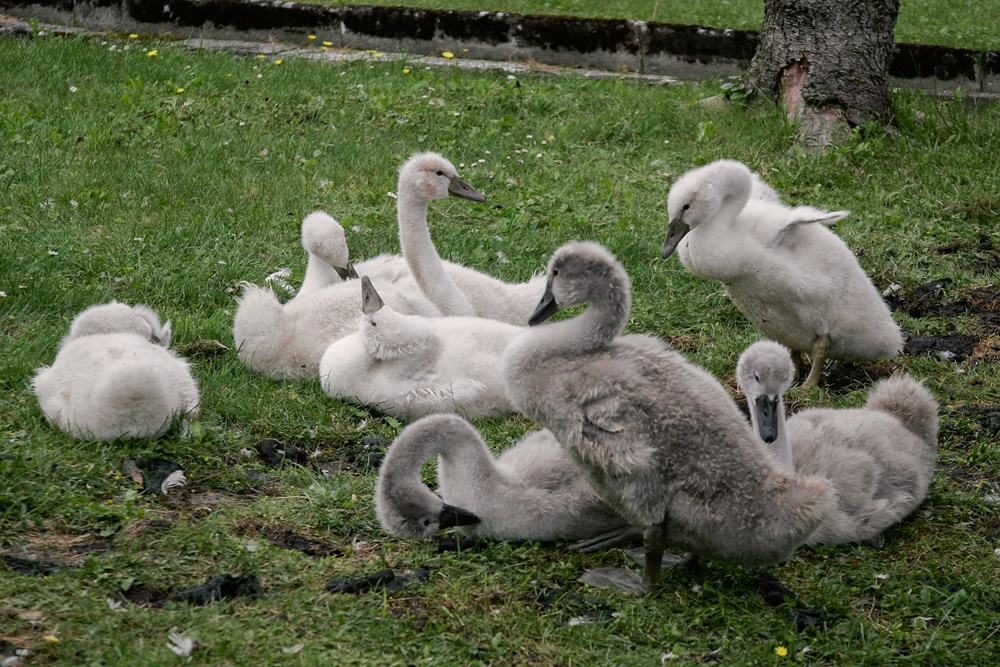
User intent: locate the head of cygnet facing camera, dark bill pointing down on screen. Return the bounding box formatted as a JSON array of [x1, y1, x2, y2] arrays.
[[736, 340, 795, 443]]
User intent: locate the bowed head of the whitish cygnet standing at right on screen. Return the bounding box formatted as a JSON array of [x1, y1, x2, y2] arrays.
[[660, 160, 753, 259]]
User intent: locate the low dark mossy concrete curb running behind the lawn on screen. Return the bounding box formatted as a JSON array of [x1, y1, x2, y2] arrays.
[[0, 0, 1000, 94]]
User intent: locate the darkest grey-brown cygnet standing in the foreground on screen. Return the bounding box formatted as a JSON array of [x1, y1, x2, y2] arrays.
[[504, 242, 835, 587]]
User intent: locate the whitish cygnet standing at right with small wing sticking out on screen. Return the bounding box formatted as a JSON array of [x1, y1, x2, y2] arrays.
[[660, 160, 903, 387]]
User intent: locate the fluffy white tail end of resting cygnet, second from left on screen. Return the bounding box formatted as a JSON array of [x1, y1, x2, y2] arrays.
[[233, 283, 286, 379]]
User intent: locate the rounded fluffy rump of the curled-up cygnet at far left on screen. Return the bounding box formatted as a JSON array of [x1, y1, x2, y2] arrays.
[[91, 362, 178, 440]]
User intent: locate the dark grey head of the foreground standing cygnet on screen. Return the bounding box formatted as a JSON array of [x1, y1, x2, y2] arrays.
[[528, 241, 631, 333]]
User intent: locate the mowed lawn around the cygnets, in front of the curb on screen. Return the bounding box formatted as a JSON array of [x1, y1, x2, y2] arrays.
[[0, 34, 1000, 667]]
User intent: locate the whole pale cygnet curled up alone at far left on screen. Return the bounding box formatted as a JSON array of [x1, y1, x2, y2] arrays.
[[33, 301, 199, 440]]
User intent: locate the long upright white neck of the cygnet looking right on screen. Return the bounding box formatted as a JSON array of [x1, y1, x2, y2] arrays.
[[396, 180, 476, 316]]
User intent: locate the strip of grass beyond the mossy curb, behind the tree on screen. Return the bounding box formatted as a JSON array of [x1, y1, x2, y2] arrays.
[[305, 0, 1000, 51]]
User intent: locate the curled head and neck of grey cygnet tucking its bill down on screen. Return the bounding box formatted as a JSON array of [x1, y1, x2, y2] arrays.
[[375, 415, 479, 540]]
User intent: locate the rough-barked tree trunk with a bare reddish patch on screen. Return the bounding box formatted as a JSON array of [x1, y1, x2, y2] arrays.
[[746, 0, 899, 147]]
